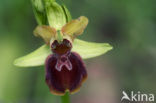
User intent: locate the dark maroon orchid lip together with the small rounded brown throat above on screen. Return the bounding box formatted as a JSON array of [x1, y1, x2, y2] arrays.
[[45, 39, 87, 95]]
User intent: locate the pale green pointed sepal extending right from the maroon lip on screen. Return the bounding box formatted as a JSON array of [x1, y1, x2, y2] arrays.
[[72, 39, 113, 59]]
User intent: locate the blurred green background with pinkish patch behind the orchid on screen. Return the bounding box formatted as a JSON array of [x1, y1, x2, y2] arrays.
[[0, 0, 156, 103]]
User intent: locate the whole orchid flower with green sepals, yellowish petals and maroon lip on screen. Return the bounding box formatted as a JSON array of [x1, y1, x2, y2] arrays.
[[14, 0, 112, 95]]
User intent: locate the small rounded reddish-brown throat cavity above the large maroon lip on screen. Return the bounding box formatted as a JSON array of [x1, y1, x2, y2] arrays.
[[51, 39, 72, 55]]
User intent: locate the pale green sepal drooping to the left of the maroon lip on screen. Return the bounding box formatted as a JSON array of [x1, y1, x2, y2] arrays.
[[14, 45, 51, 67]]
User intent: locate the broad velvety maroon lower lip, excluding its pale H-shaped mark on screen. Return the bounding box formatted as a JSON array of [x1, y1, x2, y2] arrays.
[[45, 52, 87, 95]]
